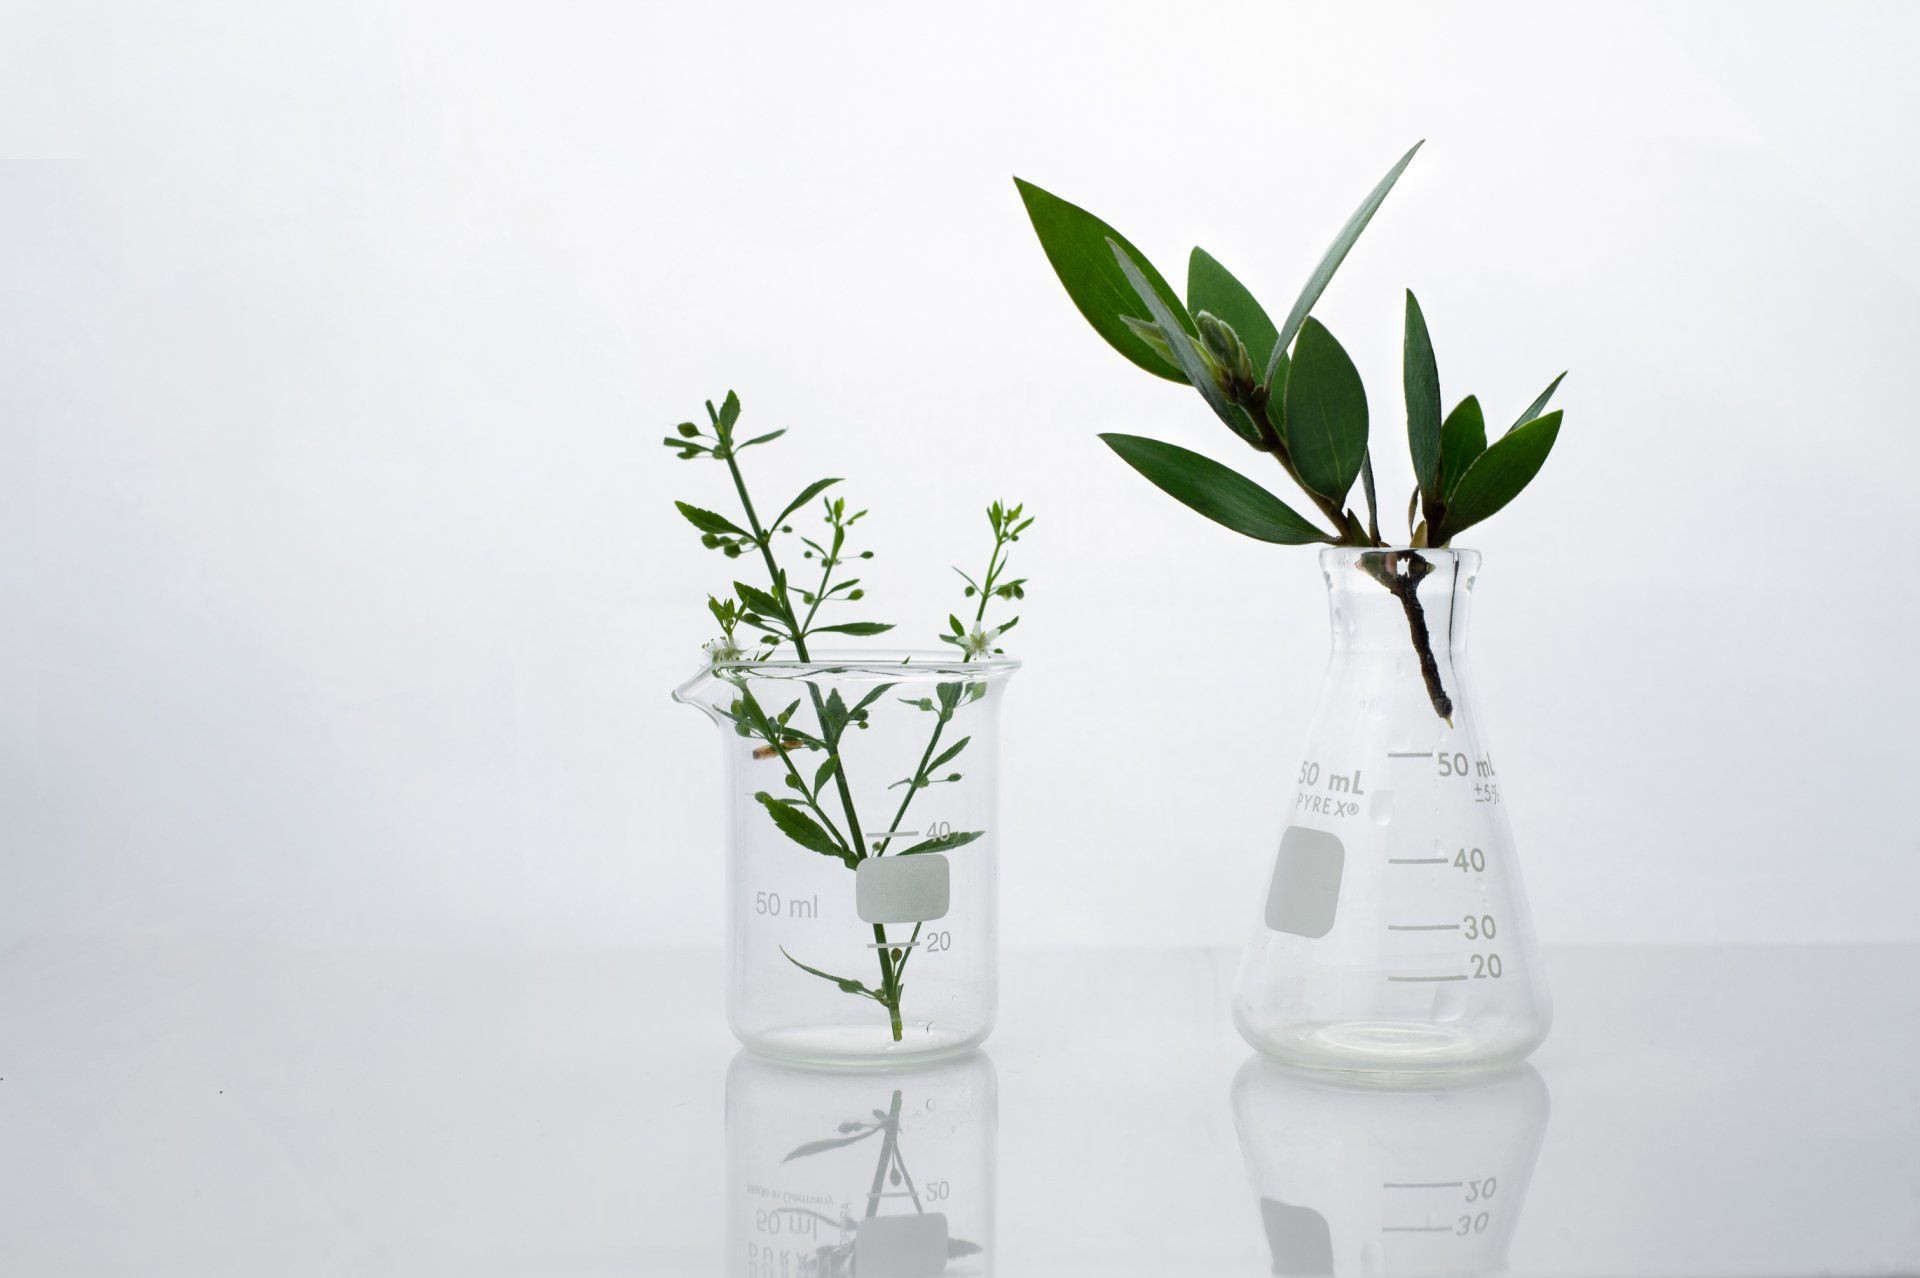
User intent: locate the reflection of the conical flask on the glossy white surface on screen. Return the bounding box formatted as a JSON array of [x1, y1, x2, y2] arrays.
[[1233, 1057, 1551, 1276]]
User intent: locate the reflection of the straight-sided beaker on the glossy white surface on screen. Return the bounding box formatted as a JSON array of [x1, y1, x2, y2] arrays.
[[726, 1052, 996, 1278]]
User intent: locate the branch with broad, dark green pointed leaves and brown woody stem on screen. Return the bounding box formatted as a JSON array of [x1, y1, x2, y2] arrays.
[[1014, 144, 1567, 718]]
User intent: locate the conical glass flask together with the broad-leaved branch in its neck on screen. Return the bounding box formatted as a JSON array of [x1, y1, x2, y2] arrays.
[[1016, 144, 1565, 1071]]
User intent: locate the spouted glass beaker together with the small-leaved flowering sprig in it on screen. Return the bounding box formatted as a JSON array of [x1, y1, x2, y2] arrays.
[[666, 391, 1033, 1059]]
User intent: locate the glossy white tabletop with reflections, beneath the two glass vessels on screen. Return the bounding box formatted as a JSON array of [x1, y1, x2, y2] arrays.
[[0, 938, 1920, 1278]]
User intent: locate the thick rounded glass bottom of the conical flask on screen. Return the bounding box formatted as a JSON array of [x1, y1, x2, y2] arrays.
[[1236, 1017, 1546, 1075]]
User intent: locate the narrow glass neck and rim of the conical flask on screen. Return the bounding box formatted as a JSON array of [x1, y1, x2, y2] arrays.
[[1321, 547, 1480, 660]]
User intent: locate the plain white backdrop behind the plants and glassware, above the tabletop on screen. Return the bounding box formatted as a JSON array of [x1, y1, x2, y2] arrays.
[[0, 4, 1920, 946]]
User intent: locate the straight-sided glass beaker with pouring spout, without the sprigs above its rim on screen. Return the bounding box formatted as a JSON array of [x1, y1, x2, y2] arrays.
[[674, 652, 1020, 1063]]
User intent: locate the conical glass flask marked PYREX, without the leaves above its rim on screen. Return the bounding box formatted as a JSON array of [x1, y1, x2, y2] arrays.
[[1233, 549, 1551, 1071]]
